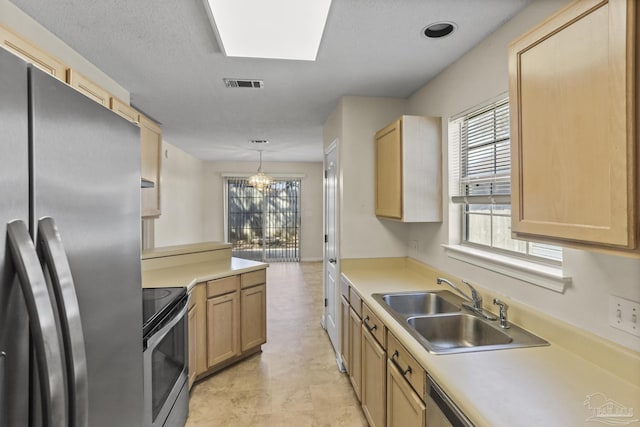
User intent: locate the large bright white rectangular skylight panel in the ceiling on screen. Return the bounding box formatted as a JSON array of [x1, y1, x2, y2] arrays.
[[203, 0, 331, 61]]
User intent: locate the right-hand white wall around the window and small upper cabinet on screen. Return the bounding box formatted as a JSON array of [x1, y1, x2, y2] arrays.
[[324, 0, 640, 350]]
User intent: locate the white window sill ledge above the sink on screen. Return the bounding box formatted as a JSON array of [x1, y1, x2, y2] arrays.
[[442, 245, 571, 294]]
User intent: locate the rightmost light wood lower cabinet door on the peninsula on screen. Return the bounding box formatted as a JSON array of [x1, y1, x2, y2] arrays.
[[241, 285, 267, 351]]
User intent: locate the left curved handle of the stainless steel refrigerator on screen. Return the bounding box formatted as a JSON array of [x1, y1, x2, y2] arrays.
[[7, 220, 68, 427]]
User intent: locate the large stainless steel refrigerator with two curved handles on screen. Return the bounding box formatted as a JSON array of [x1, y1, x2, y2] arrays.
[[0, 48, 143, 427]]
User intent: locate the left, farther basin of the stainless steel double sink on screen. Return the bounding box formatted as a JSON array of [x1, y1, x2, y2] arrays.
[[379, 291, 460, 316]]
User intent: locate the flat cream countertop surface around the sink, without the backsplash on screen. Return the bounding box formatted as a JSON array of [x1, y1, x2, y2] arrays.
[[342, 260, 640, 427]]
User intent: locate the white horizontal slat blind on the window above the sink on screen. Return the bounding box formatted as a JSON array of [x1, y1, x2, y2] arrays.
[[452, 99, 511, 205]]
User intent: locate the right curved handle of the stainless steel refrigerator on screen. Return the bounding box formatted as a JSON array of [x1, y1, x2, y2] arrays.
[[36, 217, 89, 427]]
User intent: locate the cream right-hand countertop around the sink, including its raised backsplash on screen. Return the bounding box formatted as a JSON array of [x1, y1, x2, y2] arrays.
[[342, 258, 640, 427]]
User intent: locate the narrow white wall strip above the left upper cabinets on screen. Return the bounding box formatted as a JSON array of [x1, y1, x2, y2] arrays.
[[0, 0, 129, 103]]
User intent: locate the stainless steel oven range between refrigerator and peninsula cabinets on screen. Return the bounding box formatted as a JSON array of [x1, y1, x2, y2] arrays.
[[143, 288, 189, 427]]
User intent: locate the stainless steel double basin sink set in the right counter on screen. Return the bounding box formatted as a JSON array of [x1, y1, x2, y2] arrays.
[[373, 291, 549, 354]]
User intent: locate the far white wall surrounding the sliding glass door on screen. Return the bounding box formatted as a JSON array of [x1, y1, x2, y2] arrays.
[[203, 160, 323, 261]]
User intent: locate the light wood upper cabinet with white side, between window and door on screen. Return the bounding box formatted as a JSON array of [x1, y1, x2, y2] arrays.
[[375, 116, 442, 222]]
